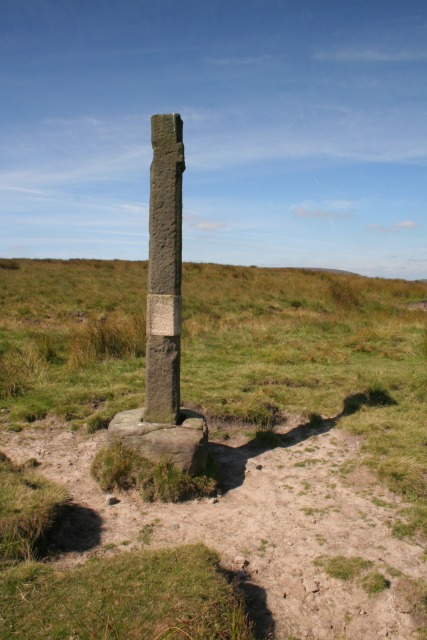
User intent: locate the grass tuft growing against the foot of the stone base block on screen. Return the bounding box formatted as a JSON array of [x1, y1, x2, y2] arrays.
[[91, 443, 217, 502]]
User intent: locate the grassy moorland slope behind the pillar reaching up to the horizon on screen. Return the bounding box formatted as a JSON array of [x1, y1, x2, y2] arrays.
[[0, 260, 427, 533]]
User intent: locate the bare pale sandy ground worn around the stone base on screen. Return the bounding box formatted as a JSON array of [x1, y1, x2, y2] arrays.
[[0, 416, 427, 640]]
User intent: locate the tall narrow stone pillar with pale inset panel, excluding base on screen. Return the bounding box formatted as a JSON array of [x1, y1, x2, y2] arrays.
[[144, 113, 185, 424]]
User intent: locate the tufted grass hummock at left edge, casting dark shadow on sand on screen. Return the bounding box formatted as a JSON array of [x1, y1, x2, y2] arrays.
[[0, 452, 67, 560]]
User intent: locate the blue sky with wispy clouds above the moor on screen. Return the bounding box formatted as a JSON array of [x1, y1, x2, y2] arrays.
[[0, 0, 427, 279]]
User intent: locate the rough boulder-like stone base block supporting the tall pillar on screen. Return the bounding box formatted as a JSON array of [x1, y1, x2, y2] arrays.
[[108, 408, 208, 475]]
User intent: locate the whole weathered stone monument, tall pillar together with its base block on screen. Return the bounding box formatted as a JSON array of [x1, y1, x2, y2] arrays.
[[108, 113, 208, 474]]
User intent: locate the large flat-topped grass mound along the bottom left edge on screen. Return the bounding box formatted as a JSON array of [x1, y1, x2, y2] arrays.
[[0, 544, 252, 640]]
